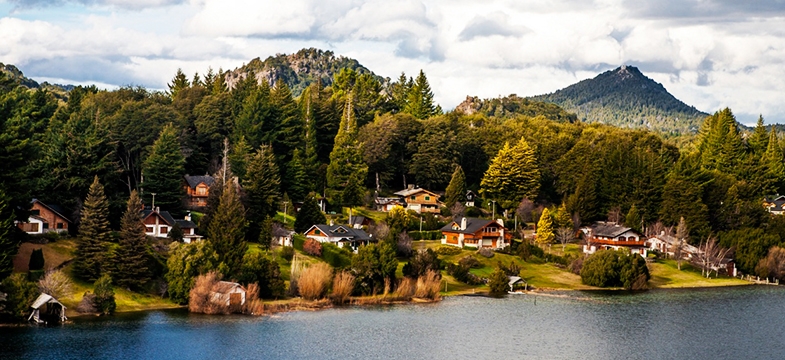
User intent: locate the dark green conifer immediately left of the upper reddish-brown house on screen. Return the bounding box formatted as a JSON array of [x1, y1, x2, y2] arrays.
[[142, 124, 185, 214]]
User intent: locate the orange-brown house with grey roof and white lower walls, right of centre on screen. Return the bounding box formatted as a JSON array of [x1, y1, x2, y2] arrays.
[[442, 218, 512, 249]]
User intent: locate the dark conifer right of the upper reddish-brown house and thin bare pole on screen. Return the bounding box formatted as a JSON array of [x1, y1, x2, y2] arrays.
[[243, 145, 281, 241]]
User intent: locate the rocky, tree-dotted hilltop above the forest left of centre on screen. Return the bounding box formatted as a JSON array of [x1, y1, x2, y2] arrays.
[[225, 48, 389, 96]]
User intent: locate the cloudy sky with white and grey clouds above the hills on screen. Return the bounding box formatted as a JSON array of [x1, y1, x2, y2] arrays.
[[0, 0, 785, 123]]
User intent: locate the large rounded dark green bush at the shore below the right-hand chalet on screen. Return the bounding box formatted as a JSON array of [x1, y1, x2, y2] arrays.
[[581, 249, 650, 290]]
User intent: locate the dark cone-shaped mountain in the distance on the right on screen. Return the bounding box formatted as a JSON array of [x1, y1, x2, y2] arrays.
[[530, 65, 708, 134]]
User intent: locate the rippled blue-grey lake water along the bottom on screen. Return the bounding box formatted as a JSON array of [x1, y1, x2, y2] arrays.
[[0, 286, 785, 359]]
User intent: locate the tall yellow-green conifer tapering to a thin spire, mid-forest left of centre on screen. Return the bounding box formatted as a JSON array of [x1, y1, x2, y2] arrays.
[[327, 94, 368, 204]]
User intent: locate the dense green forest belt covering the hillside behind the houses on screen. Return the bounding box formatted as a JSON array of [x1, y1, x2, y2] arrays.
[[0, 49, 785, 306]]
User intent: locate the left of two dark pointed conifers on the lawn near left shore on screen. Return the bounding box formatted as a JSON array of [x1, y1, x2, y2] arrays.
[[74, 176, 110, 281]]
